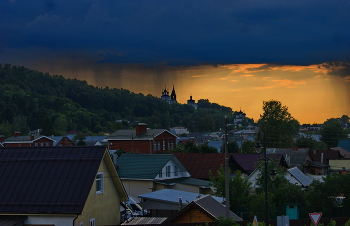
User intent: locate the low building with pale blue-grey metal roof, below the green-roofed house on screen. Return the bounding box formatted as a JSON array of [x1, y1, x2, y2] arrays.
[[138, 189, 224, 217]]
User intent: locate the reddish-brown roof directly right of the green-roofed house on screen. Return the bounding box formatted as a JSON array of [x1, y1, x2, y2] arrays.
[[175, 153, 225, 180]]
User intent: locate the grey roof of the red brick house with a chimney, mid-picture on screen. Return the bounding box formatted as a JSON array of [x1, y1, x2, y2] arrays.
[[105, 129, 176, 140]]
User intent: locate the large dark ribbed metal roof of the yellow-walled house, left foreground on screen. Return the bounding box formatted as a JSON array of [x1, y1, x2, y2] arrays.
[[0, 146, 106, 214]]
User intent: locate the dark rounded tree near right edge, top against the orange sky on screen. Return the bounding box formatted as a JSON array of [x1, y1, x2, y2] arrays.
[[320, 118, 347, 148]]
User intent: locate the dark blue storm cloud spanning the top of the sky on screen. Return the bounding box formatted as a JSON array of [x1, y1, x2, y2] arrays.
[[0, 0, 350, 65]]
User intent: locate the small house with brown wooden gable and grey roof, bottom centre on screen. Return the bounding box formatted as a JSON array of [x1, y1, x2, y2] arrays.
[[164, 195, 242, 224]]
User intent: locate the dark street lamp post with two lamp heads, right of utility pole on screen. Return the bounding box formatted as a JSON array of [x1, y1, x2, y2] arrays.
[[255, 133, 277, 226]]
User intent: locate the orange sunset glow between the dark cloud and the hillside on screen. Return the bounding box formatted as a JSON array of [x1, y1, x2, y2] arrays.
[[36, 64, 350, 124]]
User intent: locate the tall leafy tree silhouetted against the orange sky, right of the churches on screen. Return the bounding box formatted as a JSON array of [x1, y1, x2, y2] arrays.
[[258, 100, 300, 148]]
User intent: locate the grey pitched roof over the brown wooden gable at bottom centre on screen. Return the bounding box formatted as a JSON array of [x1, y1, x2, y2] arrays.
[[164, 195, 242, 223]]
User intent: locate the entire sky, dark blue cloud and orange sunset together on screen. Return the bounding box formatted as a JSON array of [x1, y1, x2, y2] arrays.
[[0, 0, 350, 124]]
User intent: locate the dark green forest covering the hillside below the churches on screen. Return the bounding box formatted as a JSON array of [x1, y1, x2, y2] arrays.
[[0, 64, 253, 137]]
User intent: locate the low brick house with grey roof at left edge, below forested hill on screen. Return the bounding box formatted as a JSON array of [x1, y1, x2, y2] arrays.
[[0, 132, 55, 147]]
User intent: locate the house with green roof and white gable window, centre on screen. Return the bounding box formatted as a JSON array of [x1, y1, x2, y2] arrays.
[[116, 154, 190, 200]]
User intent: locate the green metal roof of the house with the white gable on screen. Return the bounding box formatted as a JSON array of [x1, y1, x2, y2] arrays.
[[117, 154, 176, 179]]
